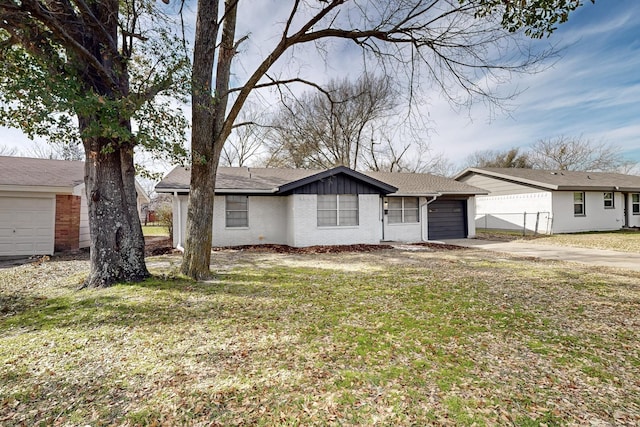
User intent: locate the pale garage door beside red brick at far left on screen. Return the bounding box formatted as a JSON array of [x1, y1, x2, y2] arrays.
[[0, 197, 56, 256]]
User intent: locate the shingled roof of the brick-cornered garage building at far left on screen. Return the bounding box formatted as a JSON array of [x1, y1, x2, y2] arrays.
[[0, 156, 84, 187]]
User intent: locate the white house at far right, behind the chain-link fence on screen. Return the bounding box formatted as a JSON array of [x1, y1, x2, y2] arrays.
[[456, 168, 640, 234]]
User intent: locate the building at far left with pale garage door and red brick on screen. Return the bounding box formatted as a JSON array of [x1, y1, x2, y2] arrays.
[[0, 156, 149, 256]]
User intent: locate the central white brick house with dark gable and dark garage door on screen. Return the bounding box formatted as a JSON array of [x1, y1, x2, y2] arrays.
[[156, 166, 486, 247]]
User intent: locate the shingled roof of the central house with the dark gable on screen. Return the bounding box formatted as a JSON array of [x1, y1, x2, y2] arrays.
[[156, 166, 487, 196]]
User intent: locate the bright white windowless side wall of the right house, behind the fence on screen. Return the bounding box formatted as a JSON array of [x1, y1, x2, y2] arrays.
[[469, 191, 552, 235]]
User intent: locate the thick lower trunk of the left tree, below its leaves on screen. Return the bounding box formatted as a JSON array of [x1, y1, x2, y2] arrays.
[[83, 141, 149, 288]]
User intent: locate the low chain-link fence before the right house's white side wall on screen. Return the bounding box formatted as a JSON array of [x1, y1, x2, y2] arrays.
[[475, 212, 552, 235]]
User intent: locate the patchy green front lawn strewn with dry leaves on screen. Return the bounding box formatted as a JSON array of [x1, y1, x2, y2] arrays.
[[0, 250, 640, 426]]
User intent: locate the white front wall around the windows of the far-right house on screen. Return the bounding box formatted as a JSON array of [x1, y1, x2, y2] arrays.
[[553, 191, 624, 233]]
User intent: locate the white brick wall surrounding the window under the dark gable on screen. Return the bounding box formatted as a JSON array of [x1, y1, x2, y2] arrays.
[[289, 194, 382, 247]]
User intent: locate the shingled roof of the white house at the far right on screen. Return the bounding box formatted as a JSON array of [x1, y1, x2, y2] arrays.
[[456, 168, 640, 191]]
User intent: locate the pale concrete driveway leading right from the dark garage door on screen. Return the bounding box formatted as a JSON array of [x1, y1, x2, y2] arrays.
[[444, 239, 640, 271]]
